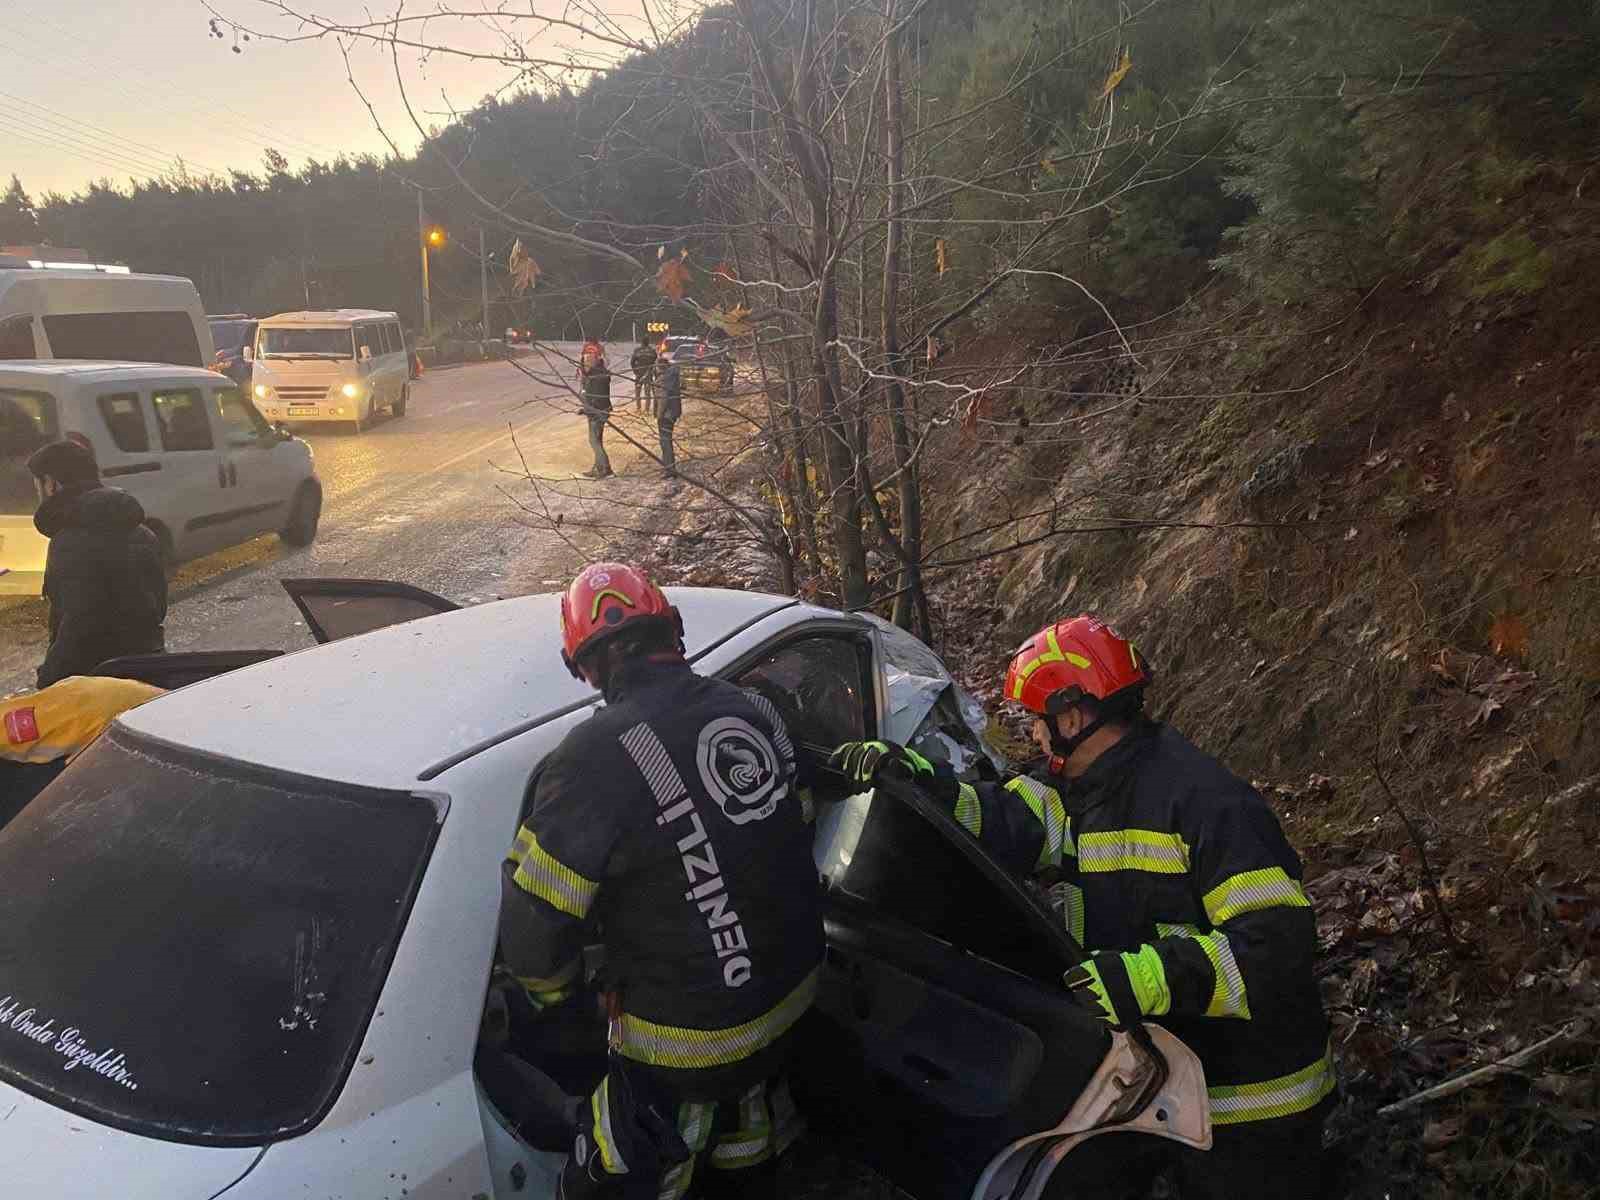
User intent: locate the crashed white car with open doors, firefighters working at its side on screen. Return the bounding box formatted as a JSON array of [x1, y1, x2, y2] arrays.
[[0, 581, 1210, 1200]]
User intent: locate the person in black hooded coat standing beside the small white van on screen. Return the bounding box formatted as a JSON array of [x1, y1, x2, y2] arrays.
[[27, 442, 166, 688]]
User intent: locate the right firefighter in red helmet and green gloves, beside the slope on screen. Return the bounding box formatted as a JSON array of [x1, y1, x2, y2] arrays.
[[834, 614, 1334, 1200]]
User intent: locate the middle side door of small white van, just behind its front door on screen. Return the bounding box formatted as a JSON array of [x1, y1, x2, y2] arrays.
[[149, 382, 235, 558]]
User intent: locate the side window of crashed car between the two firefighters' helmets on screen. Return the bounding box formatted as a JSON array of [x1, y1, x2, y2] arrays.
[[734, 634, 877, 750]]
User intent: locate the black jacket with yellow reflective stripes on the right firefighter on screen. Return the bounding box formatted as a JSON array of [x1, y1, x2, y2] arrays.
[[941, 722, 1334, 1125]]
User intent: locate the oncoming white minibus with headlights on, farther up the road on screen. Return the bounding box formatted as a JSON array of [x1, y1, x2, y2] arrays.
[[251, 309, 411, 434]]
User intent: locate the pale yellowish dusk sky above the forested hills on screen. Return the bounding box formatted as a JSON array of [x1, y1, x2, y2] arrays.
[[0, 0, 656, 200]]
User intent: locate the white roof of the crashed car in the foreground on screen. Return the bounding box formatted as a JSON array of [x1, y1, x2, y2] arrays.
[[122, 587, 798, 789]]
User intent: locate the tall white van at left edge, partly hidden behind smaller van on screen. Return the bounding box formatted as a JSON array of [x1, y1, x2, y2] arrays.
[[0, 265, 216, 366]]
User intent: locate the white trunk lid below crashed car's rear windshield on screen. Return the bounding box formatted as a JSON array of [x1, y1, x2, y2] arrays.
[[0, 1083, 261, 1200]]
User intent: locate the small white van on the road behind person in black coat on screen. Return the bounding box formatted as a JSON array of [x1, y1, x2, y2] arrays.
[[0, 362, 322, 595]]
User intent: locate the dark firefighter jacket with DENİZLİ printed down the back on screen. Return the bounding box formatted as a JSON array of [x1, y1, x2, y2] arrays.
[[501, 661, 822, 1099]]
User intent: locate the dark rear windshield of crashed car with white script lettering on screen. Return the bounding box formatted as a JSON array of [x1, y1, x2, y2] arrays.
[[0, 730, 440, 1146]]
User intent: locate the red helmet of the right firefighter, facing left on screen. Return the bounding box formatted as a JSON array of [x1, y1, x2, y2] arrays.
[[1005, 613, 1150, 717]]
